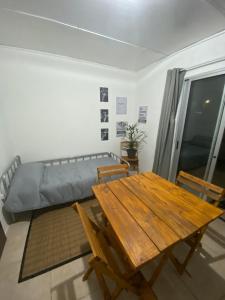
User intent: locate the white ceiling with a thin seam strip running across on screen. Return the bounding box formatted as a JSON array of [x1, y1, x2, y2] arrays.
[[0, 0, 225, 71]]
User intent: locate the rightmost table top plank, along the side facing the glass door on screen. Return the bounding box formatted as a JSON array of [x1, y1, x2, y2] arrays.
[[142, 172, 223, 223]]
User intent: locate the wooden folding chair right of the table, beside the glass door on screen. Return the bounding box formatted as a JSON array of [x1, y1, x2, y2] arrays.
[[170, 171, 225, 274]]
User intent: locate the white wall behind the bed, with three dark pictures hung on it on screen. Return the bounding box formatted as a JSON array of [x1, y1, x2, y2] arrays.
[[0, 47, 136, 162]]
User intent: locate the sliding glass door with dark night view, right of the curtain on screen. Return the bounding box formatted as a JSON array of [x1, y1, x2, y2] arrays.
[[171, 74, 225, 186]]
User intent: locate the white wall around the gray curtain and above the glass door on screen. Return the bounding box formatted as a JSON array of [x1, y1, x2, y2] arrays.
[[136, 33, 225, 170]]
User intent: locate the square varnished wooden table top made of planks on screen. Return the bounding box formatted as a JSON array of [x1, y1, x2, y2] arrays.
[[93, 172, 223, 269]]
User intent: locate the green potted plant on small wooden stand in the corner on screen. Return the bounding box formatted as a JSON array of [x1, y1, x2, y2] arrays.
[[125, 123, 147, 158]]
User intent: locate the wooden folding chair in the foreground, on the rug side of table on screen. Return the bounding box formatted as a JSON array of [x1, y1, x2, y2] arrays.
[[72, 203, 157, 300]]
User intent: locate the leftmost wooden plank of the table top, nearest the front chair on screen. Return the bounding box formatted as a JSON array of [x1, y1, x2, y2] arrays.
[[93, 184, 160, 269]]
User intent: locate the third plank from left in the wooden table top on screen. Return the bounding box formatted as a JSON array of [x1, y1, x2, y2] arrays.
[[121, 175, 198, 239]]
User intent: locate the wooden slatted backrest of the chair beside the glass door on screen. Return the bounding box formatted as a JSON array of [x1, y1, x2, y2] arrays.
[[177, 171, 225, 206]]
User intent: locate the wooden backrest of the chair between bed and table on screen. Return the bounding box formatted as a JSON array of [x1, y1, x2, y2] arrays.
[[97, 164, 129, 183]]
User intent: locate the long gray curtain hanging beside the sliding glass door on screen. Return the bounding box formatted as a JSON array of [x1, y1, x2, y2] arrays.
[[153, 69, 185, 178]]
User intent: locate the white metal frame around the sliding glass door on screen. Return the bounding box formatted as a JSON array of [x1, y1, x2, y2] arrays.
[[169, 68, 225, 182]]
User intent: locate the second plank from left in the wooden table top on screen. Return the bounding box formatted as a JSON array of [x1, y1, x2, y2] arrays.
[[107, 180, 180, 251]]
